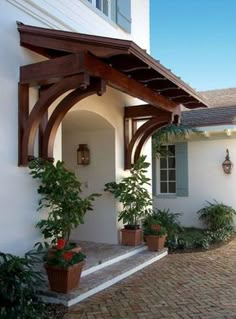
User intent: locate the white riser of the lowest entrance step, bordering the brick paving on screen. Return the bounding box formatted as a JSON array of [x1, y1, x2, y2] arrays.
[[42, 250, 168, 307]]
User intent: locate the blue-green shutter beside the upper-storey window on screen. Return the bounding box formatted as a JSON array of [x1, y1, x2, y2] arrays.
[[116, 0, 131, 33]]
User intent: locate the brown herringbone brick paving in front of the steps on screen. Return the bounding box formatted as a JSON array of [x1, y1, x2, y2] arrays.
[[64, 239, 236, 319]]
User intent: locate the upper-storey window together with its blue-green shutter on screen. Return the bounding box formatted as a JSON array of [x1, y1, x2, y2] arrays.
[[87, 0, 131, 33]]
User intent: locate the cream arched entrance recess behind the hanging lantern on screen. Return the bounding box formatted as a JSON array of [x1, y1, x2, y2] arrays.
[[62, 108, 117, 242]]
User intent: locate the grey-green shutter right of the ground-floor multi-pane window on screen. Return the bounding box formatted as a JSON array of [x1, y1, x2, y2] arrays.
[[175, 142, 188, 196]]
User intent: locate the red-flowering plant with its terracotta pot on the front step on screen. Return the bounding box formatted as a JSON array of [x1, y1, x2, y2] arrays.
[[44, 238, 86, 293]]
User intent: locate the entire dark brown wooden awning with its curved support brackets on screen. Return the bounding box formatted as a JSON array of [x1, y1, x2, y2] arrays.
[[18, 23, 206, 168]]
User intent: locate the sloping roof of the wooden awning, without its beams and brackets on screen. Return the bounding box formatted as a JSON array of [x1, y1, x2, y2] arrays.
[[18, 23, 207, 109]]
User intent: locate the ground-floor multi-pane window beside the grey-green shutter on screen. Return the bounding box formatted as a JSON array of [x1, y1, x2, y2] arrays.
[[160, 145, 176, 194]]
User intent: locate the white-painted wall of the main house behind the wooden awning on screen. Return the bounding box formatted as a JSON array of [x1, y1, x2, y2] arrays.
[[0, 0, 149, 254]]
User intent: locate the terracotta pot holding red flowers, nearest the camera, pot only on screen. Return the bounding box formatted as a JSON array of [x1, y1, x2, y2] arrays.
[[45, 261, 84, 294]]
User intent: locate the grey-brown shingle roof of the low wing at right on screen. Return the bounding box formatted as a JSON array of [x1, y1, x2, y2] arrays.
[[181, 88, 236, 127]]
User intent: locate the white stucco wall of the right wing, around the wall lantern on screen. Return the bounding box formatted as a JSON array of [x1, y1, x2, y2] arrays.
[[154, 133, 236, 227]]
